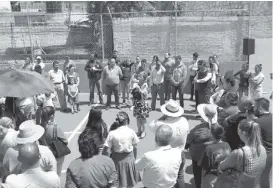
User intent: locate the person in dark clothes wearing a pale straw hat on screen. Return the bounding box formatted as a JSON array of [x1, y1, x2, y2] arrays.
[[186, 104, 219, 188]]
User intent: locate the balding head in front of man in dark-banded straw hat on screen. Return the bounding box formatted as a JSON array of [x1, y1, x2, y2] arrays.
[[155, 125, 173, 146]]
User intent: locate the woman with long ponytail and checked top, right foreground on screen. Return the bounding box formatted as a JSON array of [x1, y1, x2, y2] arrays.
[[216, 120, 266, 188]]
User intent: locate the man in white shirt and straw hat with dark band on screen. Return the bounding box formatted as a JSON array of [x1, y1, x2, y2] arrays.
[[149, 99, 189, 149]]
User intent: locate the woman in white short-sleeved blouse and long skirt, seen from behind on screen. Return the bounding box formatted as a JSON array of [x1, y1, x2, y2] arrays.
[[103, 111, 139, 187]]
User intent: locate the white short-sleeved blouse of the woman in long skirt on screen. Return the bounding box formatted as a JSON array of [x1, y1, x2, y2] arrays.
[[104, 125, 139, 153]]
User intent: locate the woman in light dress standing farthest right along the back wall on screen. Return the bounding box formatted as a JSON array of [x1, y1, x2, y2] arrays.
[[249, 64, 264, 100]]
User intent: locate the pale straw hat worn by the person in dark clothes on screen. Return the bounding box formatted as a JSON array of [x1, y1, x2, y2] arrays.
[[197, 104, 218, 124]]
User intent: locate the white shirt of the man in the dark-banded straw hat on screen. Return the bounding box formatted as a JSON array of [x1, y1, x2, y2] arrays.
[[149, 117, 190, 149]]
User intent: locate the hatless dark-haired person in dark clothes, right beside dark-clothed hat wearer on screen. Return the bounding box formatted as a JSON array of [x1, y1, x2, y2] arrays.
[[201, 126, 231, 188]]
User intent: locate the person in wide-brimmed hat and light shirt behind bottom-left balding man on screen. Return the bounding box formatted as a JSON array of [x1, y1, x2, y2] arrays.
[[3, 120, 57, 174]]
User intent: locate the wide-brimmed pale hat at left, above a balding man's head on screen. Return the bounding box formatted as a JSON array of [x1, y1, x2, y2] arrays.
[[16, 120, 45, 144]]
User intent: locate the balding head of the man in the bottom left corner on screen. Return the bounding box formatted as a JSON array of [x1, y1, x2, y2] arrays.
[[18, 143, 40, 166]]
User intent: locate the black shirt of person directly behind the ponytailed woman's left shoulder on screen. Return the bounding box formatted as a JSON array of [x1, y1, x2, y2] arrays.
[[225, 112, 246, 150]]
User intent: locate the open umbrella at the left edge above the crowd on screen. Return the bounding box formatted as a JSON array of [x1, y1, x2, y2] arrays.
[[0, 68, 54, 98]]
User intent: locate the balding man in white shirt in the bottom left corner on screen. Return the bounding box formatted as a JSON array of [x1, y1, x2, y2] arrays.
[[1, 143, 61, 188]]
